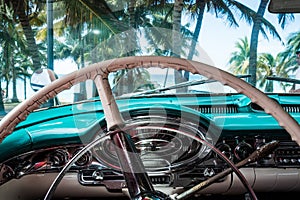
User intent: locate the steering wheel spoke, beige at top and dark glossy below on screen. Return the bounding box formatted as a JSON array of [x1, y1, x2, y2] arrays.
[[95, 75, 158, 199]]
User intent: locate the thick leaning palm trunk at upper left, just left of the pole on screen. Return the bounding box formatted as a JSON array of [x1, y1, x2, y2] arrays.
[[12, 0, 41, 69]]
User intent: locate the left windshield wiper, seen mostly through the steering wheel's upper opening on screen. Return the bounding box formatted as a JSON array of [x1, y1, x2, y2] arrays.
[[134, 74, 251, 96]]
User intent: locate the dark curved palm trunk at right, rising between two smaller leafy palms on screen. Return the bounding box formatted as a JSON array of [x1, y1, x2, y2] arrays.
[[249, 0, 269, 86]]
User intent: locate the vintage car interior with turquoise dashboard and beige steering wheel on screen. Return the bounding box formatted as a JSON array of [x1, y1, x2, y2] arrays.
[[0, 0, 300, 200]]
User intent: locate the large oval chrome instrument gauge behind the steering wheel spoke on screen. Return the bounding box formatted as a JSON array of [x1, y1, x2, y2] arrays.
[[93, 117, 207, 171]]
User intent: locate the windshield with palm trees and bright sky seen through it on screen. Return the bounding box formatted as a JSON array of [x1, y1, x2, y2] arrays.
[[0, 0, 300, 108]]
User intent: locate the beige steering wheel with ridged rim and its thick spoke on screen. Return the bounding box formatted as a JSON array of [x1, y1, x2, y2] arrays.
[[0, 56, 300, 199]]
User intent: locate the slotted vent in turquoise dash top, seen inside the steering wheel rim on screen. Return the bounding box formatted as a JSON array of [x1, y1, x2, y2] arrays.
[[191, 105, 238, 114]]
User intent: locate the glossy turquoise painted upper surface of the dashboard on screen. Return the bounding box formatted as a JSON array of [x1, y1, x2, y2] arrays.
[[0, 94, 300, 160]]
